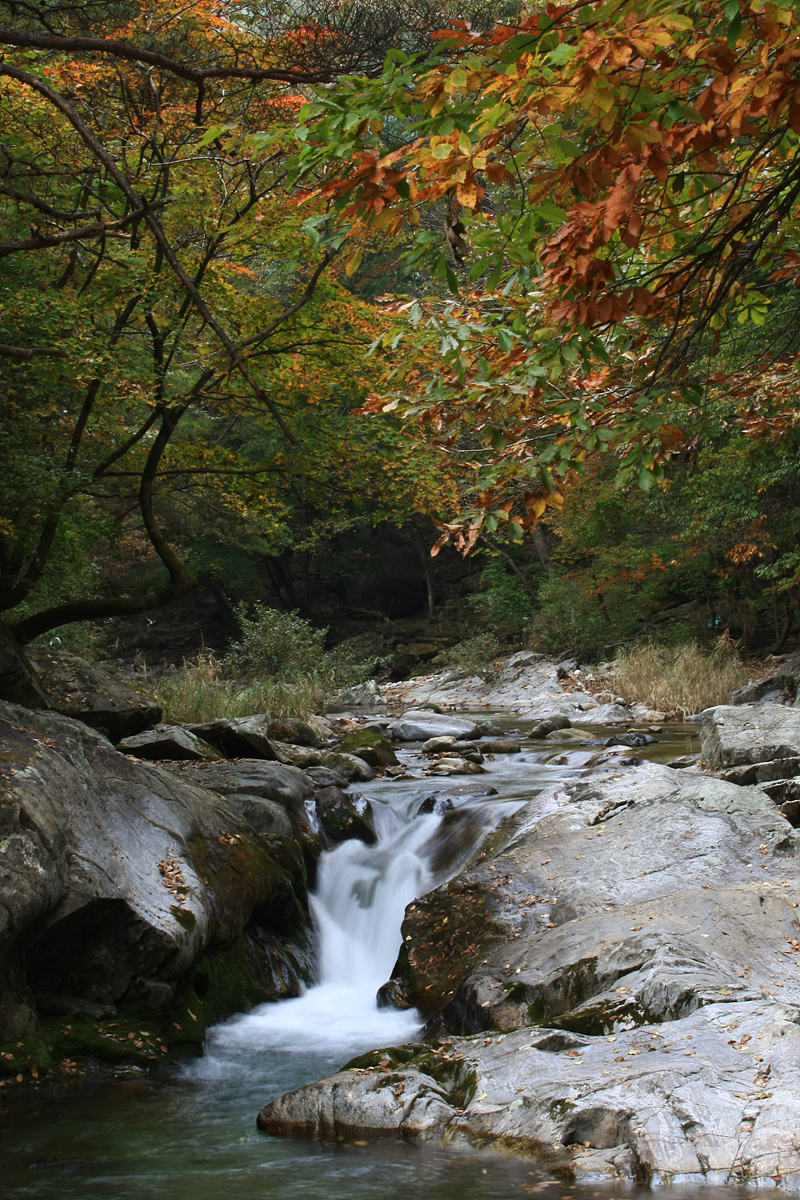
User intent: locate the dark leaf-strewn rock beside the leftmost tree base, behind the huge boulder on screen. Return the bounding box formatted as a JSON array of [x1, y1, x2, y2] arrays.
[[25, 646, 161, 742]]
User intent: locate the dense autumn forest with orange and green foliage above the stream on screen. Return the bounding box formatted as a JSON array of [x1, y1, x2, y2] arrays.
[[0, 0, 800, 677]]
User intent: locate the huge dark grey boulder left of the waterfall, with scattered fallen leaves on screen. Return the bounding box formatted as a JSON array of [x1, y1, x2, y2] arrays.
[[0, 704, 306, 1032]]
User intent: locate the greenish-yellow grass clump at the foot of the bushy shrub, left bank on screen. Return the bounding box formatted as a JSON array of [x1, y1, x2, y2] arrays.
[[148, 650, 336, 725]]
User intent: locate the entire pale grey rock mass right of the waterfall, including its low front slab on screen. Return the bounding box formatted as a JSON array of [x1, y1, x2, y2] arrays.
[[259, 763, 800, 1188]]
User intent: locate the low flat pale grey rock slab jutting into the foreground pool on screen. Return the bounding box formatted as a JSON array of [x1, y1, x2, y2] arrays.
[[258, 1001, 800, 1190]]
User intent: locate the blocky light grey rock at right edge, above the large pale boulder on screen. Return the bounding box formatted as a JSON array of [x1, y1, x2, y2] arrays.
[[700, 704, 800, 769]]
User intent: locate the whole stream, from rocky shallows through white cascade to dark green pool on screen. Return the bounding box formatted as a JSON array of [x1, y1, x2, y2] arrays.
[[0, 713, 767, 1200]]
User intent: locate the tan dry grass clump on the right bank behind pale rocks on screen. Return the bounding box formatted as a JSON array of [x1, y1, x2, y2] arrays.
[[610, 634, 748, 716]]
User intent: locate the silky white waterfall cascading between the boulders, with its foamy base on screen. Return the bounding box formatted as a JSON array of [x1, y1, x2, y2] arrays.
[[191, 785, 517, 1078]]
